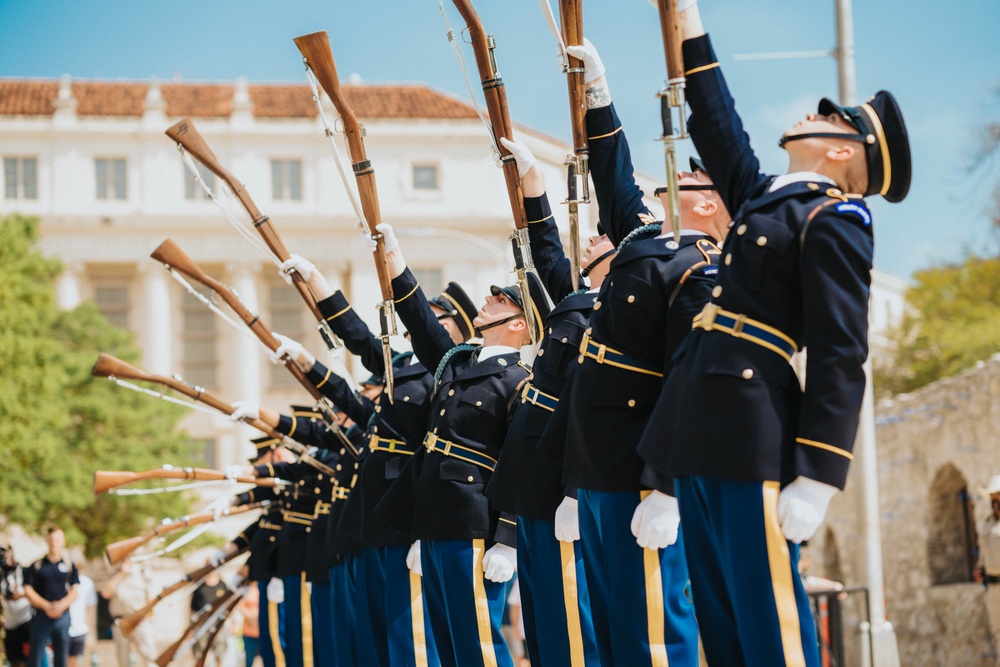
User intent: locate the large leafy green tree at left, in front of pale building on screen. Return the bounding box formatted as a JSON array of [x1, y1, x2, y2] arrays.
[[0, 215, 197, 556]]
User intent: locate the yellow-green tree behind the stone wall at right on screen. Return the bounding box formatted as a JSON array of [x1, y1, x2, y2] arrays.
[[873, 255, 1000, 395]]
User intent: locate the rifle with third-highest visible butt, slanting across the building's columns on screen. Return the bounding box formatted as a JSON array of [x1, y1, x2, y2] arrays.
[[150, 239, 353, 450]]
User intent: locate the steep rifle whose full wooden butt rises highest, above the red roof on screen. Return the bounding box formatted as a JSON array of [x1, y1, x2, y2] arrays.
[[294, 31, 397, 403]]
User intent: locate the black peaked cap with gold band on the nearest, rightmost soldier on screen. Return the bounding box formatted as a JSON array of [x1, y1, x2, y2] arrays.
[[819, 90, 911, 202]]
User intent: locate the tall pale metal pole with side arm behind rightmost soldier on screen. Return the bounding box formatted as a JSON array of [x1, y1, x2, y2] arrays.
[[735, 0, 899, 667]]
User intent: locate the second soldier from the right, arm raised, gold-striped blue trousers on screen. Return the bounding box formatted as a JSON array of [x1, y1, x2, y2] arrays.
[[539, 37, 729, 665]]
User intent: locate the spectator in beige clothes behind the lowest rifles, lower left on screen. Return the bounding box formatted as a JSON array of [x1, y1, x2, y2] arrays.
[[101, 558, 156, 667]]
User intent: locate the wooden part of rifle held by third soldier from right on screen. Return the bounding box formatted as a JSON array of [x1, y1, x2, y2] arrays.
[[454, 0, 528, 229]]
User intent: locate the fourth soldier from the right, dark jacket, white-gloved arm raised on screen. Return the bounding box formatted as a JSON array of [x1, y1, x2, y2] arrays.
[[364, 223, 547, 667]]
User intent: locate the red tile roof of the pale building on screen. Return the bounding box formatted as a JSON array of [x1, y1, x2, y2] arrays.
[[0, 79, 476, 119]]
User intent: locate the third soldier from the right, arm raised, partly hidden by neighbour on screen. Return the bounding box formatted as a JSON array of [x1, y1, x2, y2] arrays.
[[487, 139, 615, 667]]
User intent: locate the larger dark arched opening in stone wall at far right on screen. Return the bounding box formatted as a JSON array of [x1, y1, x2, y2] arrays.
[[927, 463, 976, 585]]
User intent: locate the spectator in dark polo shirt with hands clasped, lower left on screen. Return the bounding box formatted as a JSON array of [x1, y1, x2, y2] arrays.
[[24, 526, 80, 667]]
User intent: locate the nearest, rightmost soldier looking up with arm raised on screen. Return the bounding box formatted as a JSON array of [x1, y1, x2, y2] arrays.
[[639, 0, 910, 665]]
